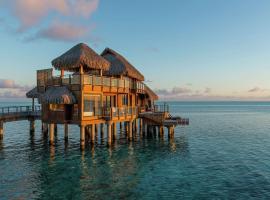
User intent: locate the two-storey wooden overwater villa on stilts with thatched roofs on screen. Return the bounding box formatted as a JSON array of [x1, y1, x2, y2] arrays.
[[0, 43, 188, 147]]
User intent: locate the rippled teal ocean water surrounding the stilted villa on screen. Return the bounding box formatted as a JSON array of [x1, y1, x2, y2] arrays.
[[0, 102, 270, 199]]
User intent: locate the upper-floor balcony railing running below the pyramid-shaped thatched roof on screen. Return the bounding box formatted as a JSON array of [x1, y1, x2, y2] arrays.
[[38, 74, 144, 92]]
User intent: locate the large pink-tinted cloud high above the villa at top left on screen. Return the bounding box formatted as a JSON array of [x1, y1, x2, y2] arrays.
[[5, 0, 99, 41]]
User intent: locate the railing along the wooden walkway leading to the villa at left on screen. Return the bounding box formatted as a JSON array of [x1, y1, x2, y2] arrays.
[[0, 106, 41, 115]]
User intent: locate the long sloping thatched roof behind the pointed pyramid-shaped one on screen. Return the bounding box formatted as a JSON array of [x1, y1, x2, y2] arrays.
[[101, 48, 144, 81]]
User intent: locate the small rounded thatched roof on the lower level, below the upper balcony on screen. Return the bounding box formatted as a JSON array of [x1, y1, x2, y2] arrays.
[[41, 86, 76, 104]]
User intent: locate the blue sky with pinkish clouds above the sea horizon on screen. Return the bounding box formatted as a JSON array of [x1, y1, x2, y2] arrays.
[[0, 0, 270, 101]]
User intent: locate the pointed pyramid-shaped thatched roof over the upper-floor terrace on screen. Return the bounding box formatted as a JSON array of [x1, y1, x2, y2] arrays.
[[52, 43, 110, 72]]
